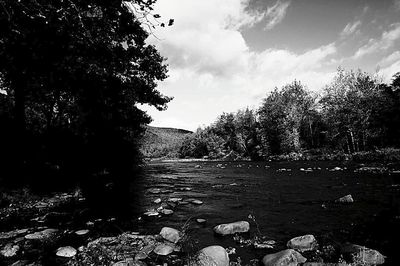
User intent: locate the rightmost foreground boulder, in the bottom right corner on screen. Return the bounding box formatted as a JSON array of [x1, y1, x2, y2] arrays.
[[341, 244, 385, 266]]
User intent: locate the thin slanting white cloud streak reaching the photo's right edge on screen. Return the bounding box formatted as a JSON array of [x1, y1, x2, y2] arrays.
[[354, 23, 400, 59]]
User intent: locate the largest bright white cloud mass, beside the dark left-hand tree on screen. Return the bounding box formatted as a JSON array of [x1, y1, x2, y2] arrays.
[[146, 0, 336, 130]]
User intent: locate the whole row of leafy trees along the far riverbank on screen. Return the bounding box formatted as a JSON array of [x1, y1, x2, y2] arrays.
[[179, 68, 400, 160]]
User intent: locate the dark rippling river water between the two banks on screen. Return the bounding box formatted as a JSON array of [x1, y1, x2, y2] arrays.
[[135, 162, 400, 265]]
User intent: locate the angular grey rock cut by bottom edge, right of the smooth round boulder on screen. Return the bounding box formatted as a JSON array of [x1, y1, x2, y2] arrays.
[[262, 249, 307, 266]]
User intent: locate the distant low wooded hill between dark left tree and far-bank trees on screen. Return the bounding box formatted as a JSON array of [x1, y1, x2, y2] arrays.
[[141, 126, 193, 158]]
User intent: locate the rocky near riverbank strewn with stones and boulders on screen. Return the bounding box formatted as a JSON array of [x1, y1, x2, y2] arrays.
[[0, 186, 385, 266]]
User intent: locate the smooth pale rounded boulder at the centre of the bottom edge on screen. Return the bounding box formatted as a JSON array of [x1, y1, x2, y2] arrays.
[[189, 246, 229, 266]]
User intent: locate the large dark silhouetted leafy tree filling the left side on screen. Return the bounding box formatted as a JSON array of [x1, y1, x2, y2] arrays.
[[0, 0, 171, 192]]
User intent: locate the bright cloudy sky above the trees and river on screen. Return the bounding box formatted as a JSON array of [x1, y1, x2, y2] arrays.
[[141, 0, 400, 131]]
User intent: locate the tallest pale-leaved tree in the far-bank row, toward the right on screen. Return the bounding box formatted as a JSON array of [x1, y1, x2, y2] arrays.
[[321, 69, 380, 153]]
